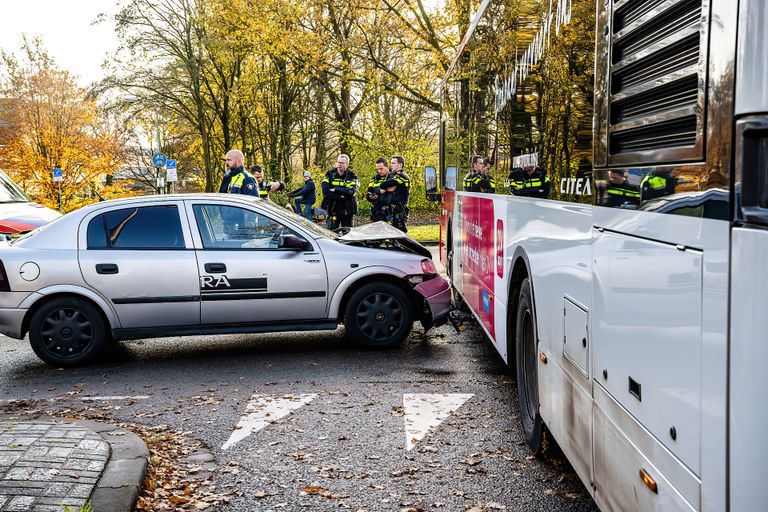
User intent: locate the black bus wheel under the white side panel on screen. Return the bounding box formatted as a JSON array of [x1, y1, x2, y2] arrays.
[[515, 278, 546, 455]]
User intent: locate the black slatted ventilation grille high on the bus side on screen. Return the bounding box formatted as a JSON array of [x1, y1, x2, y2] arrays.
[[608, 0, 706, 163]]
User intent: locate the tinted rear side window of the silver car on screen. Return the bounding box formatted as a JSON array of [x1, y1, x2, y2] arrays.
[[87, 205, 185, 250]]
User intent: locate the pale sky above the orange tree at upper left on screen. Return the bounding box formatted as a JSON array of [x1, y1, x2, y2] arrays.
[[0, 0, 118, 87]]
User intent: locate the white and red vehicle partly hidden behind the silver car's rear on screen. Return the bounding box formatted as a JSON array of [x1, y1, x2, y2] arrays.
[[0, 171, 60, 237]]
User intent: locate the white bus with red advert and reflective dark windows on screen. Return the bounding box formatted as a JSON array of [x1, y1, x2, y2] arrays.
[[426, 0, 768, 512]]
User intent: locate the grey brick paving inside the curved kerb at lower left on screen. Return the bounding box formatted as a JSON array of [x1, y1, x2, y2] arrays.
[[0, 422, 109, 512]]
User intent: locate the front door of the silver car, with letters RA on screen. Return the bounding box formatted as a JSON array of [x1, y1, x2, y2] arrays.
[[187, 201, 328, 324]]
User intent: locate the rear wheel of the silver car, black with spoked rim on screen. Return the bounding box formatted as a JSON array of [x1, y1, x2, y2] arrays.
[[29, 297, 107, 367]]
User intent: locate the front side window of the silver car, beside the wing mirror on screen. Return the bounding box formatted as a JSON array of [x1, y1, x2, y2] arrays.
[[192, 204, 295, 249]]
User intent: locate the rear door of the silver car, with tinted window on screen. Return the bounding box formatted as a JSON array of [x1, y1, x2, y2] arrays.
[[78, 201, 200, 328]]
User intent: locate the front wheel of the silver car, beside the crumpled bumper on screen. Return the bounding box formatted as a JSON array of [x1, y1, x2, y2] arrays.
[[344, 283, 413, 348]]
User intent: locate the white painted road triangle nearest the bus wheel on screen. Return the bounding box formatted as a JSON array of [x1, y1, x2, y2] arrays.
[[403, 393, 474, 450]]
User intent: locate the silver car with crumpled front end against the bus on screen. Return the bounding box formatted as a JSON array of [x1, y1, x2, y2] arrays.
[[0, 194, 451, 366]]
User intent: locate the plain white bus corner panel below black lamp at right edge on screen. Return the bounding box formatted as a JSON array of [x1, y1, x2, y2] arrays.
[[729, 228, 768, 511]]
